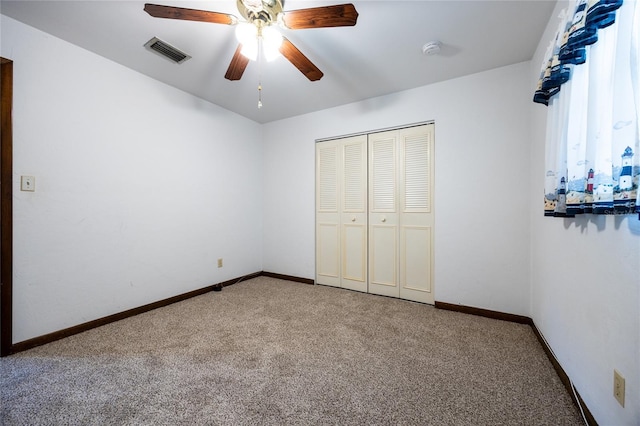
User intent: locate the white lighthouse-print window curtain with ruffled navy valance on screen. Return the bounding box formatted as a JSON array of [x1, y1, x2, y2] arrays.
[[534, 0, 640, 219]]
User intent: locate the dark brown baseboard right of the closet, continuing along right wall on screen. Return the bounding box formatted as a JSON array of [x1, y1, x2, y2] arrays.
[[435, 301, 598, 426]]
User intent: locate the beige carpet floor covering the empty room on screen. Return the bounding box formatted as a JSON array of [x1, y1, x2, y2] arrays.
[[0, 277, 582, 425]]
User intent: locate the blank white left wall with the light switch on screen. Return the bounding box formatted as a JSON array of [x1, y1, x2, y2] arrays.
[[1, 16, 262, 342]]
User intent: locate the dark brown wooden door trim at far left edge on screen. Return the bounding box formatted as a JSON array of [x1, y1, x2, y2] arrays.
[[0, 58, 13, 356]]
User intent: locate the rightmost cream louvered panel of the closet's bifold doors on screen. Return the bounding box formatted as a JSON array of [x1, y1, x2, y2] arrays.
[[398, 124, 434, 304]]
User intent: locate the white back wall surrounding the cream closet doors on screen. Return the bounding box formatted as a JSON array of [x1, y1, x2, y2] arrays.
[[263, 58, 531, 316]]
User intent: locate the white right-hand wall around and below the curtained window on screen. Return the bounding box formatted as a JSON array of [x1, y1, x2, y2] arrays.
[[528, 2, 640, 425]]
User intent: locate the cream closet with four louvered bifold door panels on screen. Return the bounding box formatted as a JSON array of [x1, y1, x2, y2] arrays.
[[316, 124, 434, 303]]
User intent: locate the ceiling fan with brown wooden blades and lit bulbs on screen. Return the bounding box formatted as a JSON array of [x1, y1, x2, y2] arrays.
[[144, 0, 358, 81]]
